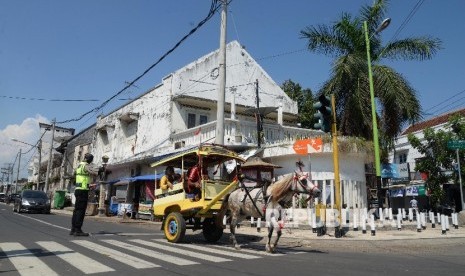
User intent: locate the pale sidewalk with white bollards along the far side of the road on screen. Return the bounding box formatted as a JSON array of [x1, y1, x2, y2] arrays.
[[52, 207, 465, 241]]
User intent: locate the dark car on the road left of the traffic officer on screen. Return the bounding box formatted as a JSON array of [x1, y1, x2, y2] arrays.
[[13, 190, 51, 214]]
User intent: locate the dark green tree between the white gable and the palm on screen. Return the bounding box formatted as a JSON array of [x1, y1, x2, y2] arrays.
[[281, 80, 315, 128]]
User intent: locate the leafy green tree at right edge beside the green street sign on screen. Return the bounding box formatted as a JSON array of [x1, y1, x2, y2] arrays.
[[408, 115, 465, 209]]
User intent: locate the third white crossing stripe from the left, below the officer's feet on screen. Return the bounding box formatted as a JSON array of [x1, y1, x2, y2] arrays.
[[72, 240, 160, 269]]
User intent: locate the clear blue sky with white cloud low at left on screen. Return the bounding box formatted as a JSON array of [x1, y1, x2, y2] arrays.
[[0, 0, 465, 176]]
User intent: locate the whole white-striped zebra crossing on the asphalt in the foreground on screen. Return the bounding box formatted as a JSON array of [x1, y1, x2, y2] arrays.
[[0, 239, 302, 276]]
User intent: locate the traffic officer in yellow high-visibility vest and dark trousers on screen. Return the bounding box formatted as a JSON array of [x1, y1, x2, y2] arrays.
[[69, 153, 100, 237]]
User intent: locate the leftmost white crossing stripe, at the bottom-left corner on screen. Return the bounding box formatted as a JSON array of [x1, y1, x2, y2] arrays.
[[0, 242, 58, 276]]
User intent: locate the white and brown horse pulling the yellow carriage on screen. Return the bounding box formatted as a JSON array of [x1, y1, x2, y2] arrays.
[[219, 172, 321, 253]]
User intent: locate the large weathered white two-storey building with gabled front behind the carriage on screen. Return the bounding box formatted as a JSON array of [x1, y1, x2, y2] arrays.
[[65, 41, 366, 207]]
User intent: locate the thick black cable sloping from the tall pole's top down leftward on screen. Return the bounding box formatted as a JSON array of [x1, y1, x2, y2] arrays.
[[57, 0, 221, 124]]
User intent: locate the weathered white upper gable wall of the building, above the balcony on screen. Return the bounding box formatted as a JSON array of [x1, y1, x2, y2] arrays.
[[172, 41, 297, 114]]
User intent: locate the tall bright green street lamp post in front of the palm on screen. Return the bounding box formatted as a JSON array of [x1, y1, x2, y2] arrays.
[[363, 18, 391, 207]]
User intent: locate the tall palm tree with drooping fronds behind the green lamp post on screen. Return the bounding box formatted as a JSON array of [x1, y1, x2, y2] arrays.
[[300, 0, 441, 141]]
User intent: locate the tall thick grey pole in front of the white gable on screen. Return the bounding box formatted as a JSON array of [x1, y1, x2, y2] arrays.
[[215, 0, 227, 145]]
